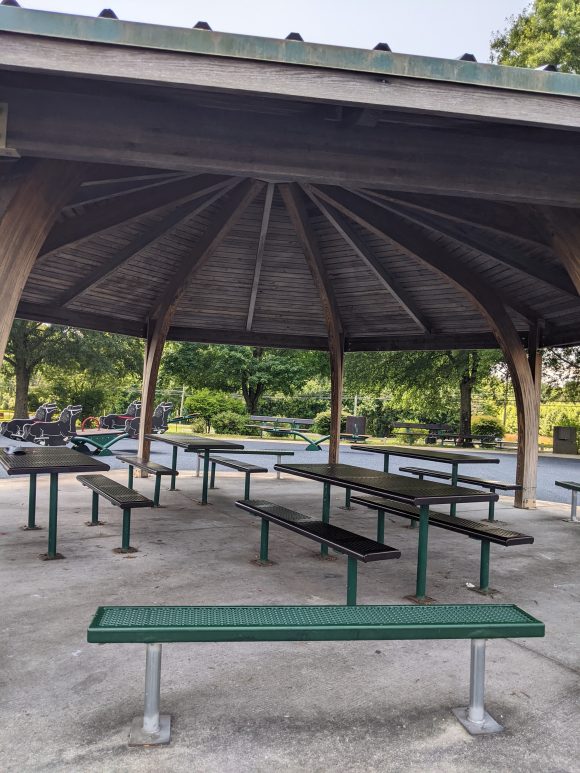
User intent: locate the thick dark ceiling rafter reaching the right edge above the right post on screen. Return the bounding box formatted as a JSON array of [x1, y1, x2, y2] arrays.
[[365, 193, 577, 296]]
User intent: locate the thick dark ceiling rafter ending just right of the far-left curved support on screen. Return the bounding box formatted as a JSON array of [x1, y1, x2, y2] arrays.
[[40, 174, 229, 258]]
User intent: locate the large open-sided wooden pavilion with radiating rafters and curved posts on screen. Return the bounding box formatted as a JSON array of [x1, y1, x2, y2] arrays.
[[0, 0, 580, 507]]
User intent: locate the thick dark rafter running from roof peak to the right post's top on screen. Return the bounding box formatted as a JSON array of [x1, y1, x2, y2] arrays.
[[315, 187, 539, 322]]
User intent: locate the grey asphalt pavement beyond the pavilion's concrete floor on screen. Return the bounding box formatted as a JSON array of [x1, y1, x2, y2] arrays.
[[0, 437, 580, 502]]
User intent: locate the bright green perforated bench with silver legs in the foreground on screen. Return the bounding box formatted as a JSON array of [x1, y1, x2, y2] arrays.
[[87, 604, 545, 746]]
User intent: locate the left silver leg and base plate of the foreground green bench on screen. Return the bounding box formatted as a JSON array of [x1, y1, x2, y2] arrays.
[[129, 644, 171, 746]]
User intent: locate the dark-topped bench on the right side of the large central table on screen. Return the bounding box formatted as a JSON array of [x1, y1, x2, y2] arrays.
[[351, 496, 534, 593]]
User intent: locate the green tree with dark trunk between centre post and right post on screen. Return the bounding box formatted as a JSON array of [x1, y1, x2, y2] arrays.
[[346, 350, 501, 436]]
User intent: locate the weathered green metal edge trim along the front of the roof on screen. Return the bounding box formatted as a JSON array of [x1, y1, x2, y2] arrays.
[[0, 6, 580, 97]]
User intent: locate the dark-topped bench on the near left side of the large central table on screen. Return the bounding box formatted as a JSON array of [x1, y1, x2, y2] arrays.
[[236, 500, 401, 606]]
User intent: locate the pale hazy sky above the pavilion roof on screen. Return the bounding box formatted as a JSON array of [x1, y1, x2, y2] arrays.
[[14, 0, 529, 62]]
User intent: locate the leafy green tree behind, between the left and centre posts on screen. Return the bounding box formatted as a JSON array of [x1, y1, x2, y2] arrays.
[[160, 343, 328, 414]]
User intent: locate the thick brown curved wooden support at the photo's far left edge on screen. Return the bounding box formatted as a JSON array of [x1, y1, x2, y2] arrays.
[[0, 161, 85, 364]]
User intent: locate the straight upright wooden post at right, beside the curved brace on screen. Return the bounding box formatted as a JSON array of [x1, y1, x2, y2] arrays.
[[512, 324, 542, 509]]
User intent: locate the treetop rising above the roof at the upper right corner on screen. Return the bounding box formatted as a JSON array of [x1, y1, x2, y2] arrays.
[[491, 0, 580, 72]]
